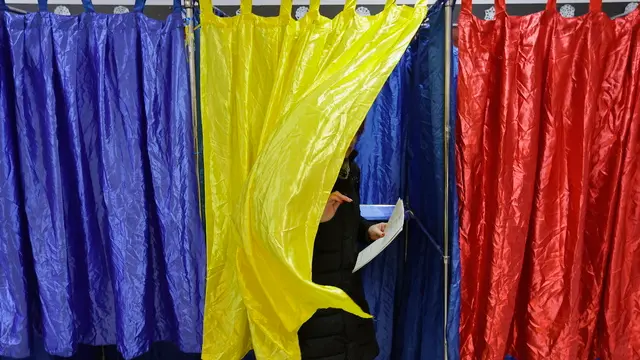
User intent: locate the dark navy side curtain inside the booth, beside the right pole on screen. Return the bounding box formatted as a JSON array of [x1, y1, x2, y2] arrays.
[[394, 1, 459, 360]]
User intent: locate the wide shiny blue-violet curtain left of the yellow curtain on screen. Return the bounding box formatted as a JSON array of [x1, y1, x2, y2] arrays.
[[0, 2, 205, 358]]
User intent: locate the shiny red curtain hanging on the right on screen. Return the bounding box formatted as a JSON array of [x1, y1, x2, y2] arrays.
[[456, 0, 640, 360]]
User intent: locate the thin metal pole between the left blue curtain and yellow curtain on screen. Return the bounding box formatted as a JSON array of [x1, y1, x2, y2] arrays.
[[184, 0, 202, 219]]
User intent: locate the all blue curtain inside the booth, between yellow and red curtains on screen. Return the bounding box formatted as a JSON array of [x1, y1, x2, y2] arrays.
[[358, 1, 460, 360]]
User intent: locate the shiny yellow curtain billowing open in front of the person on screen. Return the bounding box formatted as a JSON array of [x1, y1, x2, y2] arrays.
[[200, 0, 427, 360]]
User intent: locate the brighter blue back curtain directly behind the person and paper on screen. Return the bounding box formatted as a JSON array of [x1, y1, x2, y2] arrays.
[[356, 49, 412, 360]]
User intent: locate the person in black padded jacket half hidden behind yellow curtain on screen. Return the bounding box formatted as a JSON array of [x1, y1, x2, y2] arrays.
[[298, 125, 386, 360]]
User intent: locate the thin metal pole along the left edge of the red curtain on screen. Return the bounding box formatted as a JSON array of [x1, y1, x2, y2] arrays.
[[442, 0, 455, 360]]
